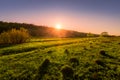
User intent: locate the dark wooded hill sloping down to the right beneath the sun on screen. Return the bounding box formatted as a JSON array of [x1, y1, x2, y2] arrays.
[[0, 21, 98, 37]]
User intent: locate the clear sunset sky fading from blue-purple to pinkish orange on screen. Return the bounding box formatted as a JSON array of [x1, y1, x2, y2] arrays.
[[0, 0, 120, 35]]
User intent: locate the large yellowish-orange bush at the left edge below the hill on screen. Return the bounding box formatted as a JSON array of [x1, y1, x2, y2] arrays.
[[0, 28, 30, 44]]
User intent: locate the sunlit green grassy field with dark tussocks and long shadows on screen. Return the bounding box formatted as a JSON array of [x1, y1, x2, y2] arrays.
[[0, 37, 120, 80]]
